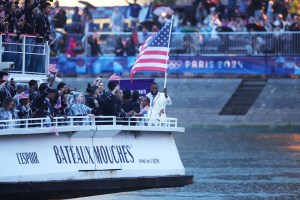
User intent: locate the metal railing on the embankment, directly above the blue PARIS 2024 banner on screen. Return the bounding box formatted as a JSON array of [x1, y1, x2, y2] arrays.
[[82, 32, 300, 56]]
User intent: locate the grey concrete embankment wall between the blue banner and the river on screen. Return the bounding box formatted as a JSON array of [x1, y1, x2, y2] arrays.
[[64, 78, 300, 127]]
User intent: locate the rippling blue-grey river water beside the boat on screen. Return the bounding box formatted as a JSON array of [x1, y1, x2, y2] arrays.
[[74, 128, 300, 200]]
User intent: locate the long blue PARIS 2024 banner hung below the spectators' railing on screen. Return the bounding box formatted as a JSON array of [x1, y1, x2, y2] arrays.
[[50, 55, 300, 76]]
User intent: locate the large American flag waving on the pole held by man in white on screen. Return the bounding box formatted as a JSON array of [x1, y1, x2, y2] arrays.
[[130, 22, 172, 78]]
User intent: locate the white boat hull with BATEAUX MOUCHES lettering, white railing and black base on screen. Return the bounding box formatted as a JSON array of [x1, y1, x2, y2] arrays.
[[0, 117, 193, 199]]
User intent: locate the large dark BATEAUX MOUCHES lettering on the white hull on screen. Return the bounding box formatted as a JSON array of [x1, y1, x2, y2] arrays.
[[53, 145, 134, 164]]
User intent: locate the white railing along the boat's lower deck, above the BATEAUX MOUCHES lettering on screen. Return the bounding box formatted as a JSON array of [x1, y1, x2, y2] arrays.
[[0, 116, 177, 135]]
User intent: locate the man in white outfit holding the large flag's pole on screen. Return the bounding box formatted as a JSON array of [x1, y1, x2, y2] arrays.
[[146, 83, 172, 118]]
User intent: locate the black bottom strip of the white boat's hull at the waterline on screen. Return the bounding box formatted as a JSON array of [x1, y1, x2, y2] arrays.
[[0, 175, 193, 199]]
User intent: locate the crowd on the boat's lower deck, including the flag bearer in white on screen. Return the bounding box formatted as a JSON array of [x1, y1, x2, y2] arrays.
[[0, 71, 172, 127]]
